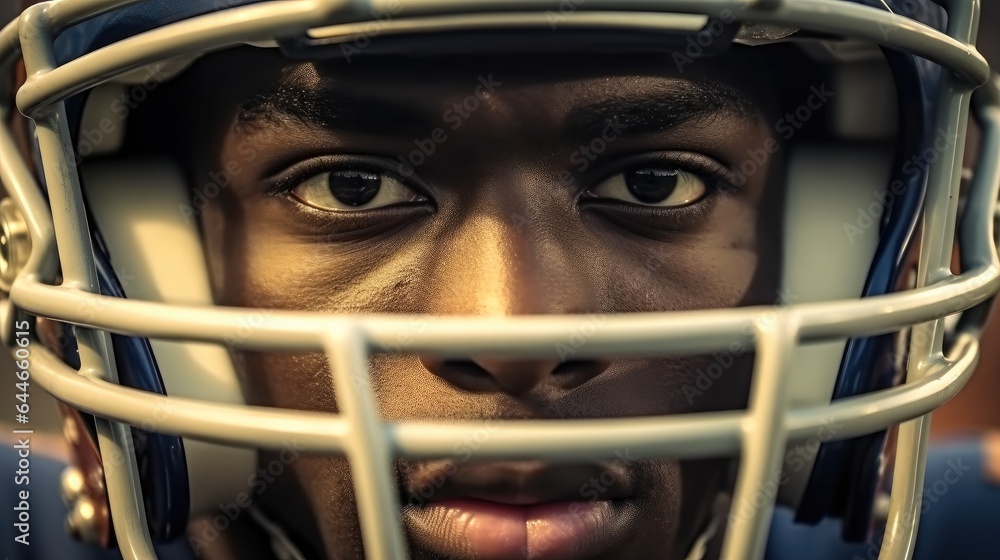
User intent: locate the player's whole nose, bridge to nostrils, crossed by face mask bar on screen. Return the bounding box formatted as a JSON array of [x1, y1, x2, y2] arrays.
[[420, 175, 610, 397]]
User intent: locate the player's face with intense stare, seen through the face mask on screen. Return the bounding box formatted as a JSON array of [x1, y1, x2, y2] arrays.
[[178, 44, 782, 558]]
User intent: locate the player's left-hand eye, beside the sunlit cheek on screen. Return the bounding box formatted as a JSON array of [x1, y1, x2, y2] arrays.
[[292, 170, 427, 211]]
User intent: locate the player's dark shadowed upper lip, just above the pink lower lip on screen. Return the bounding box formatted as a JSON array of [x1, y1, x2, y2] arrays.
[[401, 460, 633, 505]]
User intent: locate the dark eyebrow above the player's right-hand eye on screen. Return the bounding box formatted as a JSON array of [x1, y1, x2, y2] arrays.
[[566, 82, 759, 137]]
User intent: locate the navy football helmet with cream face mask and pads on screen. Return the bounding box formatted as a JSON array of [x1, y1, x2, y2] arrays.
[[0, 0, 1000, 560]]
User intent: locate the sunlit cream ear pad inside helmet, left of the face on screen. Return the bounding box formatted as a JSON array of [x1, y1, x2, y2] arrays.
[[81, 158, 256, 532]]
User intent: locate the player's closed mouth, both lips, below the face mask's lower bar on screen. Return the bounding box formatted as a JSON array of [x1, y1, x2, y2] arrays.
[[403, 462, 637, 560]]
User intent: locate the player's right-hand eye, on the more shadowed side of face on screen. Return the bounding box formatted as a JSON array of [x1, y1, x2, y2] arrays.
[[586, 168, 708, 208]]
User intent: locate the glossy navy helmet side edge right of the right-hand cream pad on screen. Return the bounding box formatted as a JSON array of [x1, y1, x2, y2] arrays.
[[788, 41, 943, 540]]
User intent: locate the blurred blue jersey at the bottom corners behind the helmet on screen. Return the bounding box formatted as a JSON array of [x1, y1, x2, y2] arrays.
[[0, 440, 1000, 560]]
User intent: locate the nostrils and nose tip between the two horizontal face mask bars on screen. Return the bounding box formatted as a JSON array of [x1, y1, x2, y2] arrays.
[[420, 356, 610, 397]]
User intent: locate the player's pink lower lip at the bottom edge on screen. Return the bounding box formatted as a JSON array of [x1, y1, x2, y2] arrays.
[[407, 500, 616, 560]]
